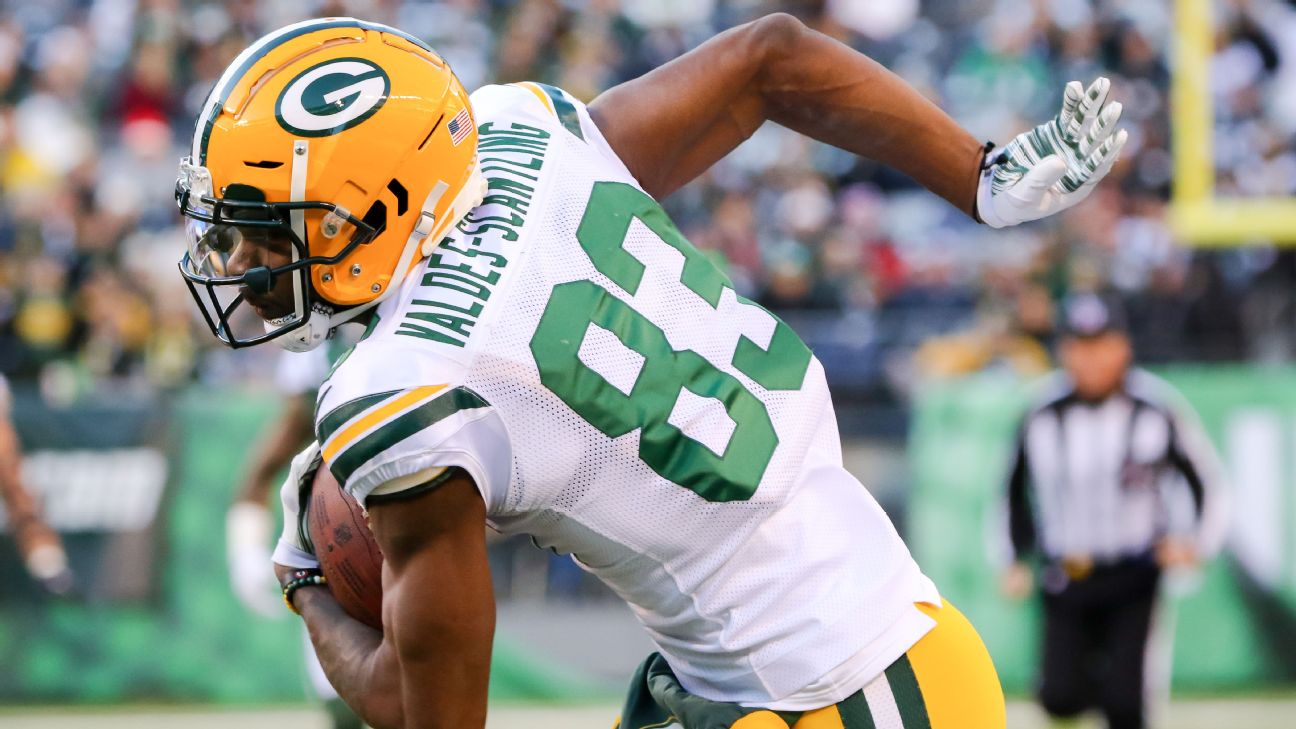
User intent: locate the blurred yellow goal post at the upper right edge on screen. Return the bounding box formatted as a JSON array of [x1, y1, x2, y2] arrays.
[[1169, 0, 1296, 246]]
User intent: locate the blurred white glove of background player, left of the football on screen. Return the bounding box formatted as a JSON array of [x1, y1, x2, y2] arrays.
[[226, 501, 284, 617]]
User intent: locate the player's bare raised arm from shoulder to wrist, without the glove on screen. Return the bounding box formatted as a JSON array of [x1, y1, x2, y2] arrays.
[[590, 13, 982, 210]]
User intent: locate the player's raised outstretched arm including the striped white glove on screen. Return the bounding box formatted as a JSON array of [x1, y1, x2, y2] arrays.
[[590, 13, 1126, 228]]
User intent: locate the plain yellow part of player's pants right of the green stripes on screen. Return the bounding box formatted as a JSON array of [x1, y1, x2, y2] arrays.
[[906, 602, 1007, 729]]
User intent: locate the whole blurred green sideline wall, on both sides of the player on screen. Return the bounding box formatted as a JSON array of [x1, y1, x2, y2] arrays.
[[0, 367, 1296, 703]]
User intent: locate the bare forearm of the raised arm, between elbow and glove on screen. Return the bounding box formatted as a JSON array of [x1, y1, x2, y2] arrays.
[[759, 18, 984, 215]]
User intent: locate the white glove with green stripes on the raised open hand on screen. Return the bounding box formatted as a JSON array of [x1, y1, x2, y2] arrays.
[[976, 77, 1129, 228]]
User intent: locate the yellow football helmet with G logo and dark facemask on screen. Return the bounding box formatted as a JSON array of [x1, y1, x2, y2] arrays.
[[175, 18, 486, 352]]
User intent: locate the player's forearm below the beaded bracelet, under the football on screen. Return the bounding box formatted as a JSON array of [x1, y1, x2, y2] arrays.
[[293, 588, 404, 729]]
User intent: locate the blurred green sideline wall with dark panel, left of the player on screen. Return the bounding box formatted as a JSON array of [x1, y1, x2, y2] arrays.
[[0, 389, 590, 703]]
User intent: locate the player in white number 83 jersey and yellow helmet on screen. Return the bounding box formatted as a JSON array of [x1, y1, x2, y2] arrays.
[[176, 14, 1125, 729]]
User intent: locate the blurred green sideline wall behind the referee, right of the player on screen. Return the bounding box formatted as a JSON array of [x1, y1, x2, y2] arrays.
[[908, 366, 1296, 691]]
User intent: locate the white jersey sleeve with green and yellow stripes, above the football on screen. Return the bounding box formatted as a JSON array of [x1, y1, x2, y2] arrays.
[[315, 355, 512, 511]]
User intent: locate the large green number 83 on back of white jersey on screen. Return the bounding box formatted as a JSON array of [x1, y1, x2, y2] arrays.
[[530, 182, 810, 501]]
